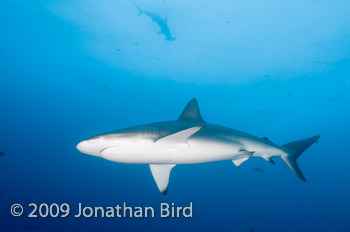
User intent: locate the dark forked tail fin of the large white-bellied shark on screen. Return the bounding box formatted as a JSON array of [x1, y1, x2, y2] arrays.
[[281, 136, 320, 182]]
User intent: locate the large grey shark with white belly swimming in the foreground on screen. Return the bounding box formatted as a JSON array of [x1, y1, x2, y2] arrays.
[[76, 99, 320, 195]]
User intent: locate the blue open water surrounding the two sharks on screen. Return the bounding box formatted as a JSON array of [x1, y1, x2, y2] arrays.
[[0, 0, 350, 232]]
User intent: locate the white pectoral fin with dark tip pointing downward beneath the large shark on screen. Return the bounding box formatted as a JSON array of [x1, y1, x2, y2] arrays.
[[149, 164, 176, 195]]
